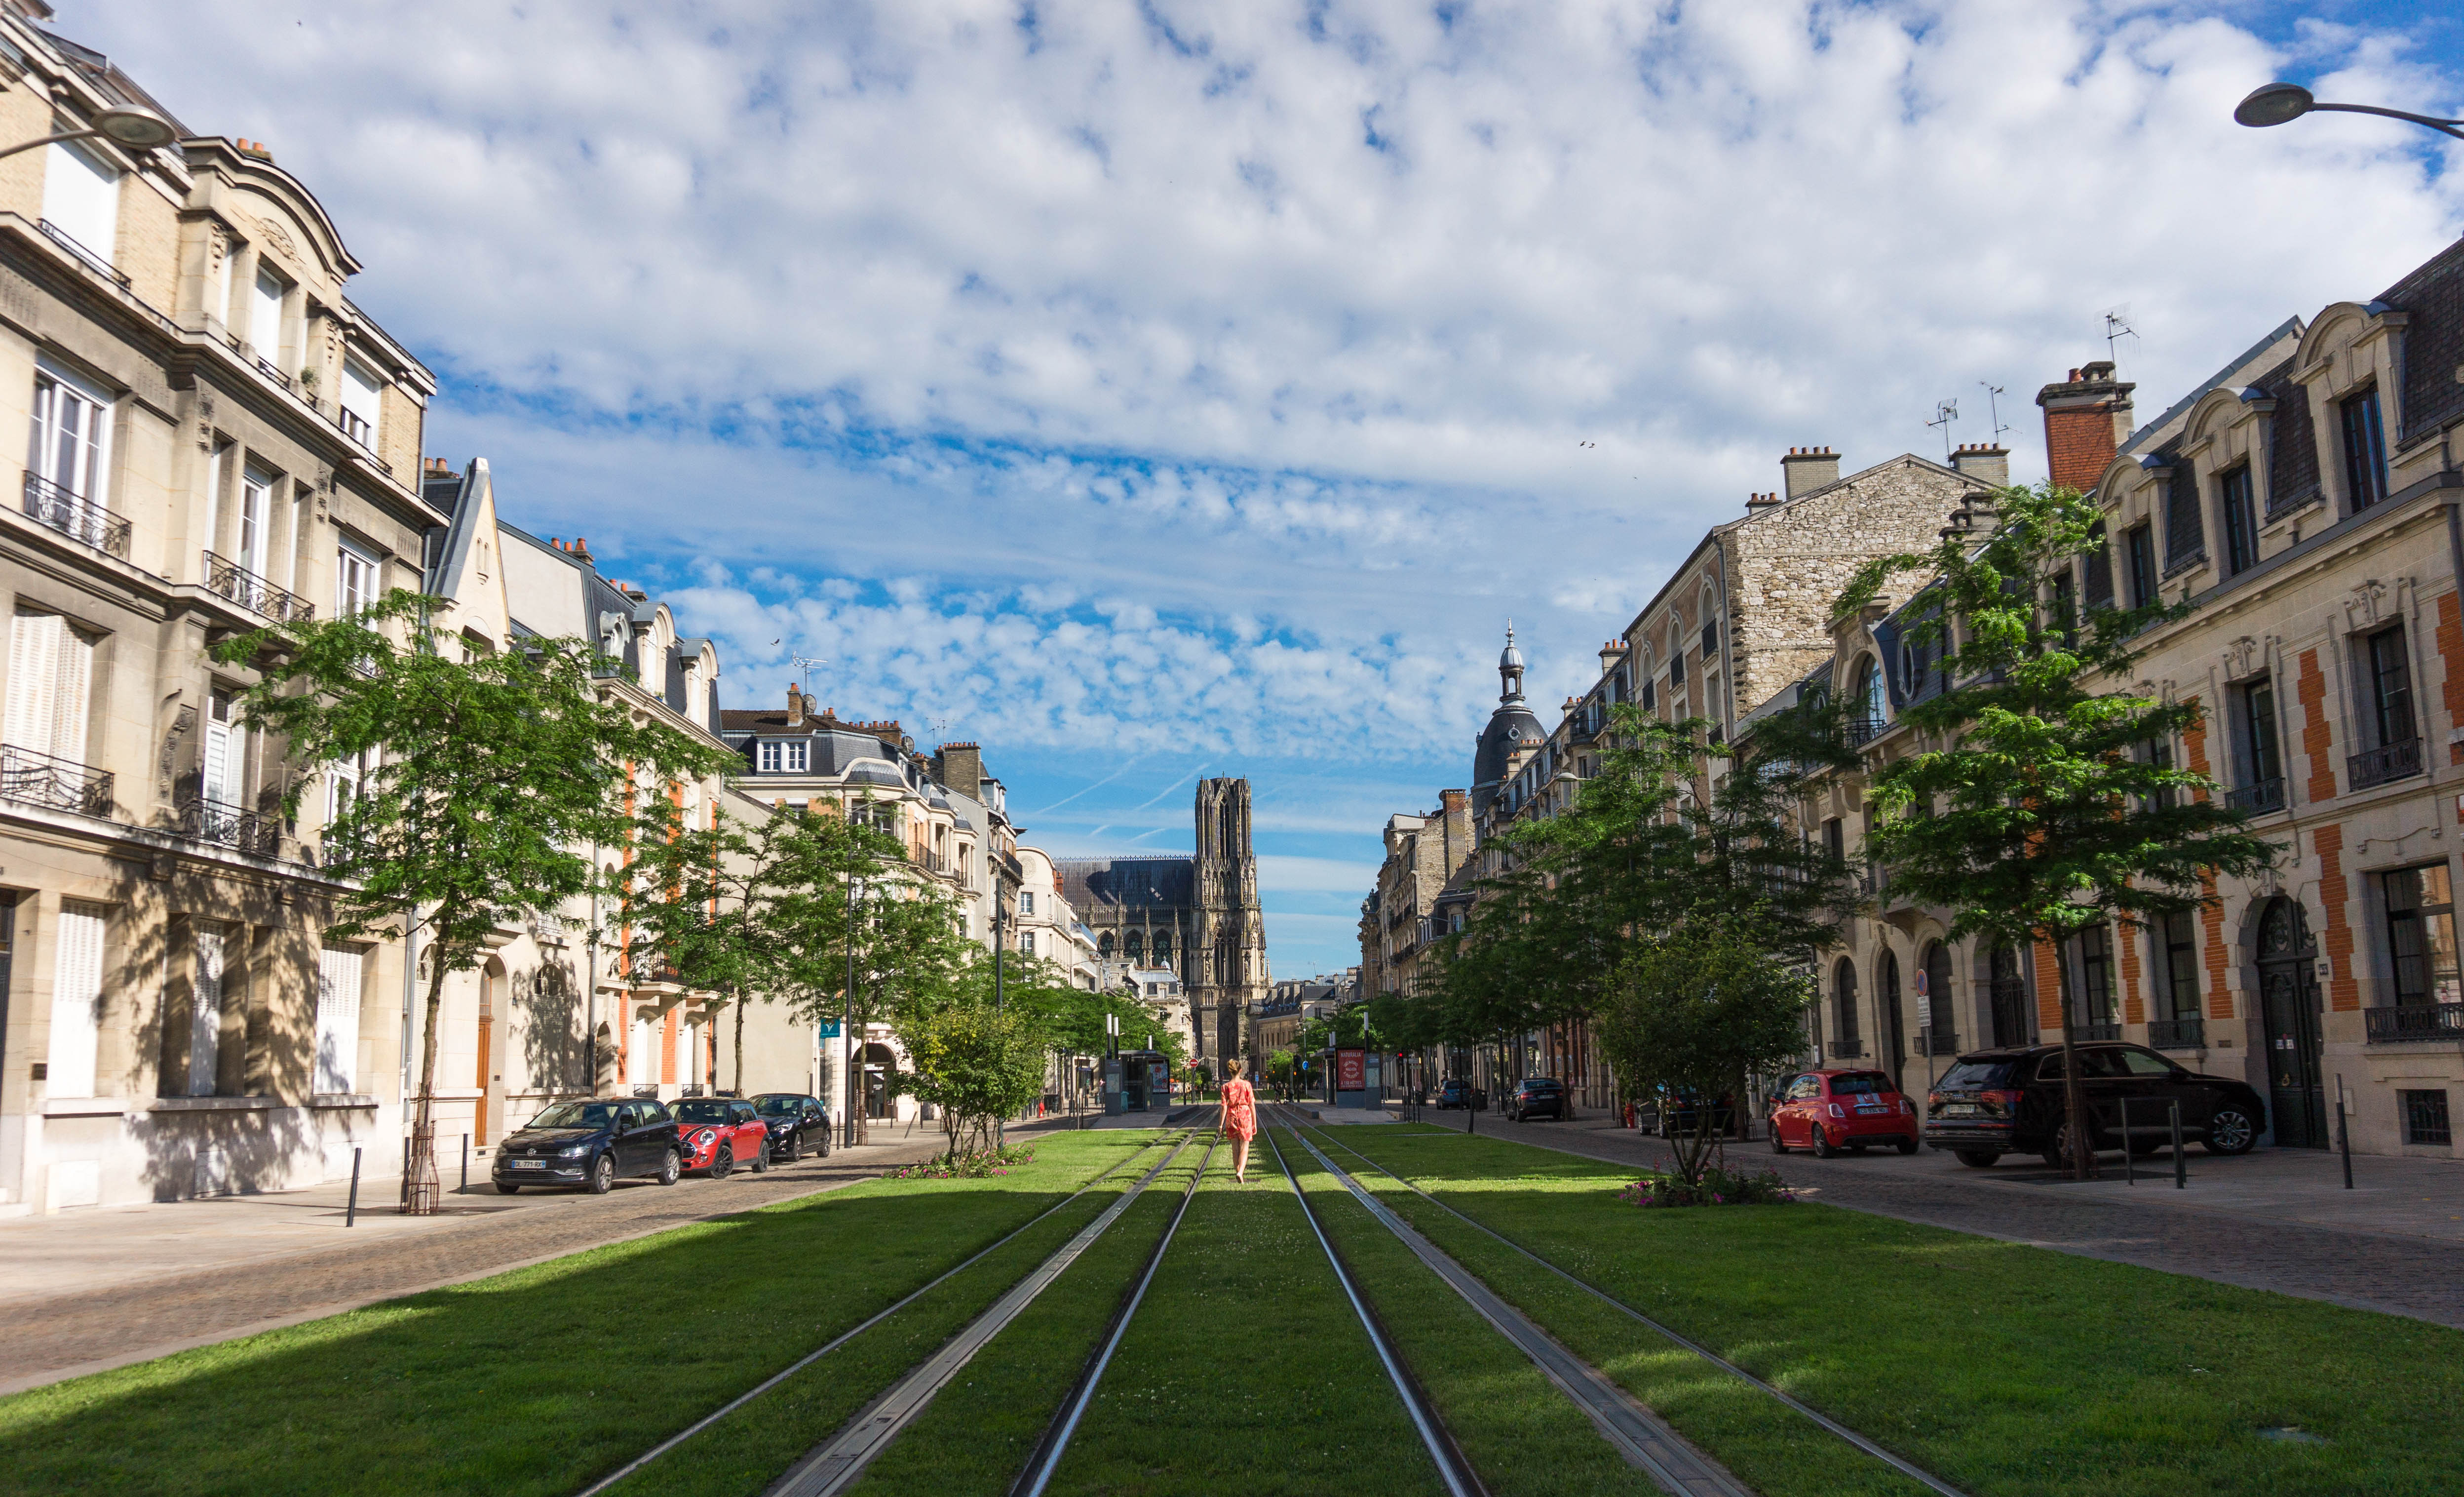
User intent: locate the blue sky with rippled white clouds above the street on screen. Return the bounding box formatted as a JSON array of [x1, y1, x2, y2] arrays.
[[54, 0, 2464, 977]]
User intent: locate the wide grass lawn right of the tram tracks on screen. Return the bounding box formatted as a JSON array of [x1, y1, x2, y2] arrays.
[[1318, 1125, 2464, 1497]]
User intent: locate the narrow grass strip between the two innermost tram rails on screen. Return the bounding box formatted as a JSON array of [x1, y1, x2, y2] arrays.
[[1047, 1144, 1441, 1497]]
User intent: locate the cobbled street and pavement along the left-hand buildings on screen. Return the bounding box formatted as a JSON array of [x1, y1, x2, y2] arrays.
[[0, 1125, 941, 1393]]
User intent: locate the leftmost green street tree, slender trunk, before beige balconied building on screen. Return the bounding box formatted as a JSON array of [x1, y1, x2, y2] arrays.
[[214, 590, 732, 1214]]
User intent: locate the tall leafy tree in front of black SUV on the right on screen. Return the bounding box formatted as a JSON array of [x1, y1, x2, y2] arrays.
[[1838, 486, 2277, 1179]]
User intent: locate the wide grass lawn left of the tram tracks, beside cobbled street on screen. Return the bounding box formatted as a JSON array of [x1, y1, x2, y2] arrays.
[[0, 1132, 1151, 1497]]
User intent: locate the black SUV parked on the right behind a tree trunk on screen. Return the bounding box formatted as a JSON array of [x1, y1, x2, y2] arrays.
[[1925, 1041, 2267, 1169]]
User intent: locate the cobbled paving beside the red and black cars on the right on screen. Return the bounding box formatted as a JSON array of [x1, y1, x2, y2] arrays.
[[1424, 1107, 2464, 1327]]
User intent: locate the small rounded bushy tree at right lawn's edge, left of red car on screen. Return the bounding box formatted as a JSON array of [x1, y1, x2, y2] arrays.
[[1594, 920, 1813, 1186]]
